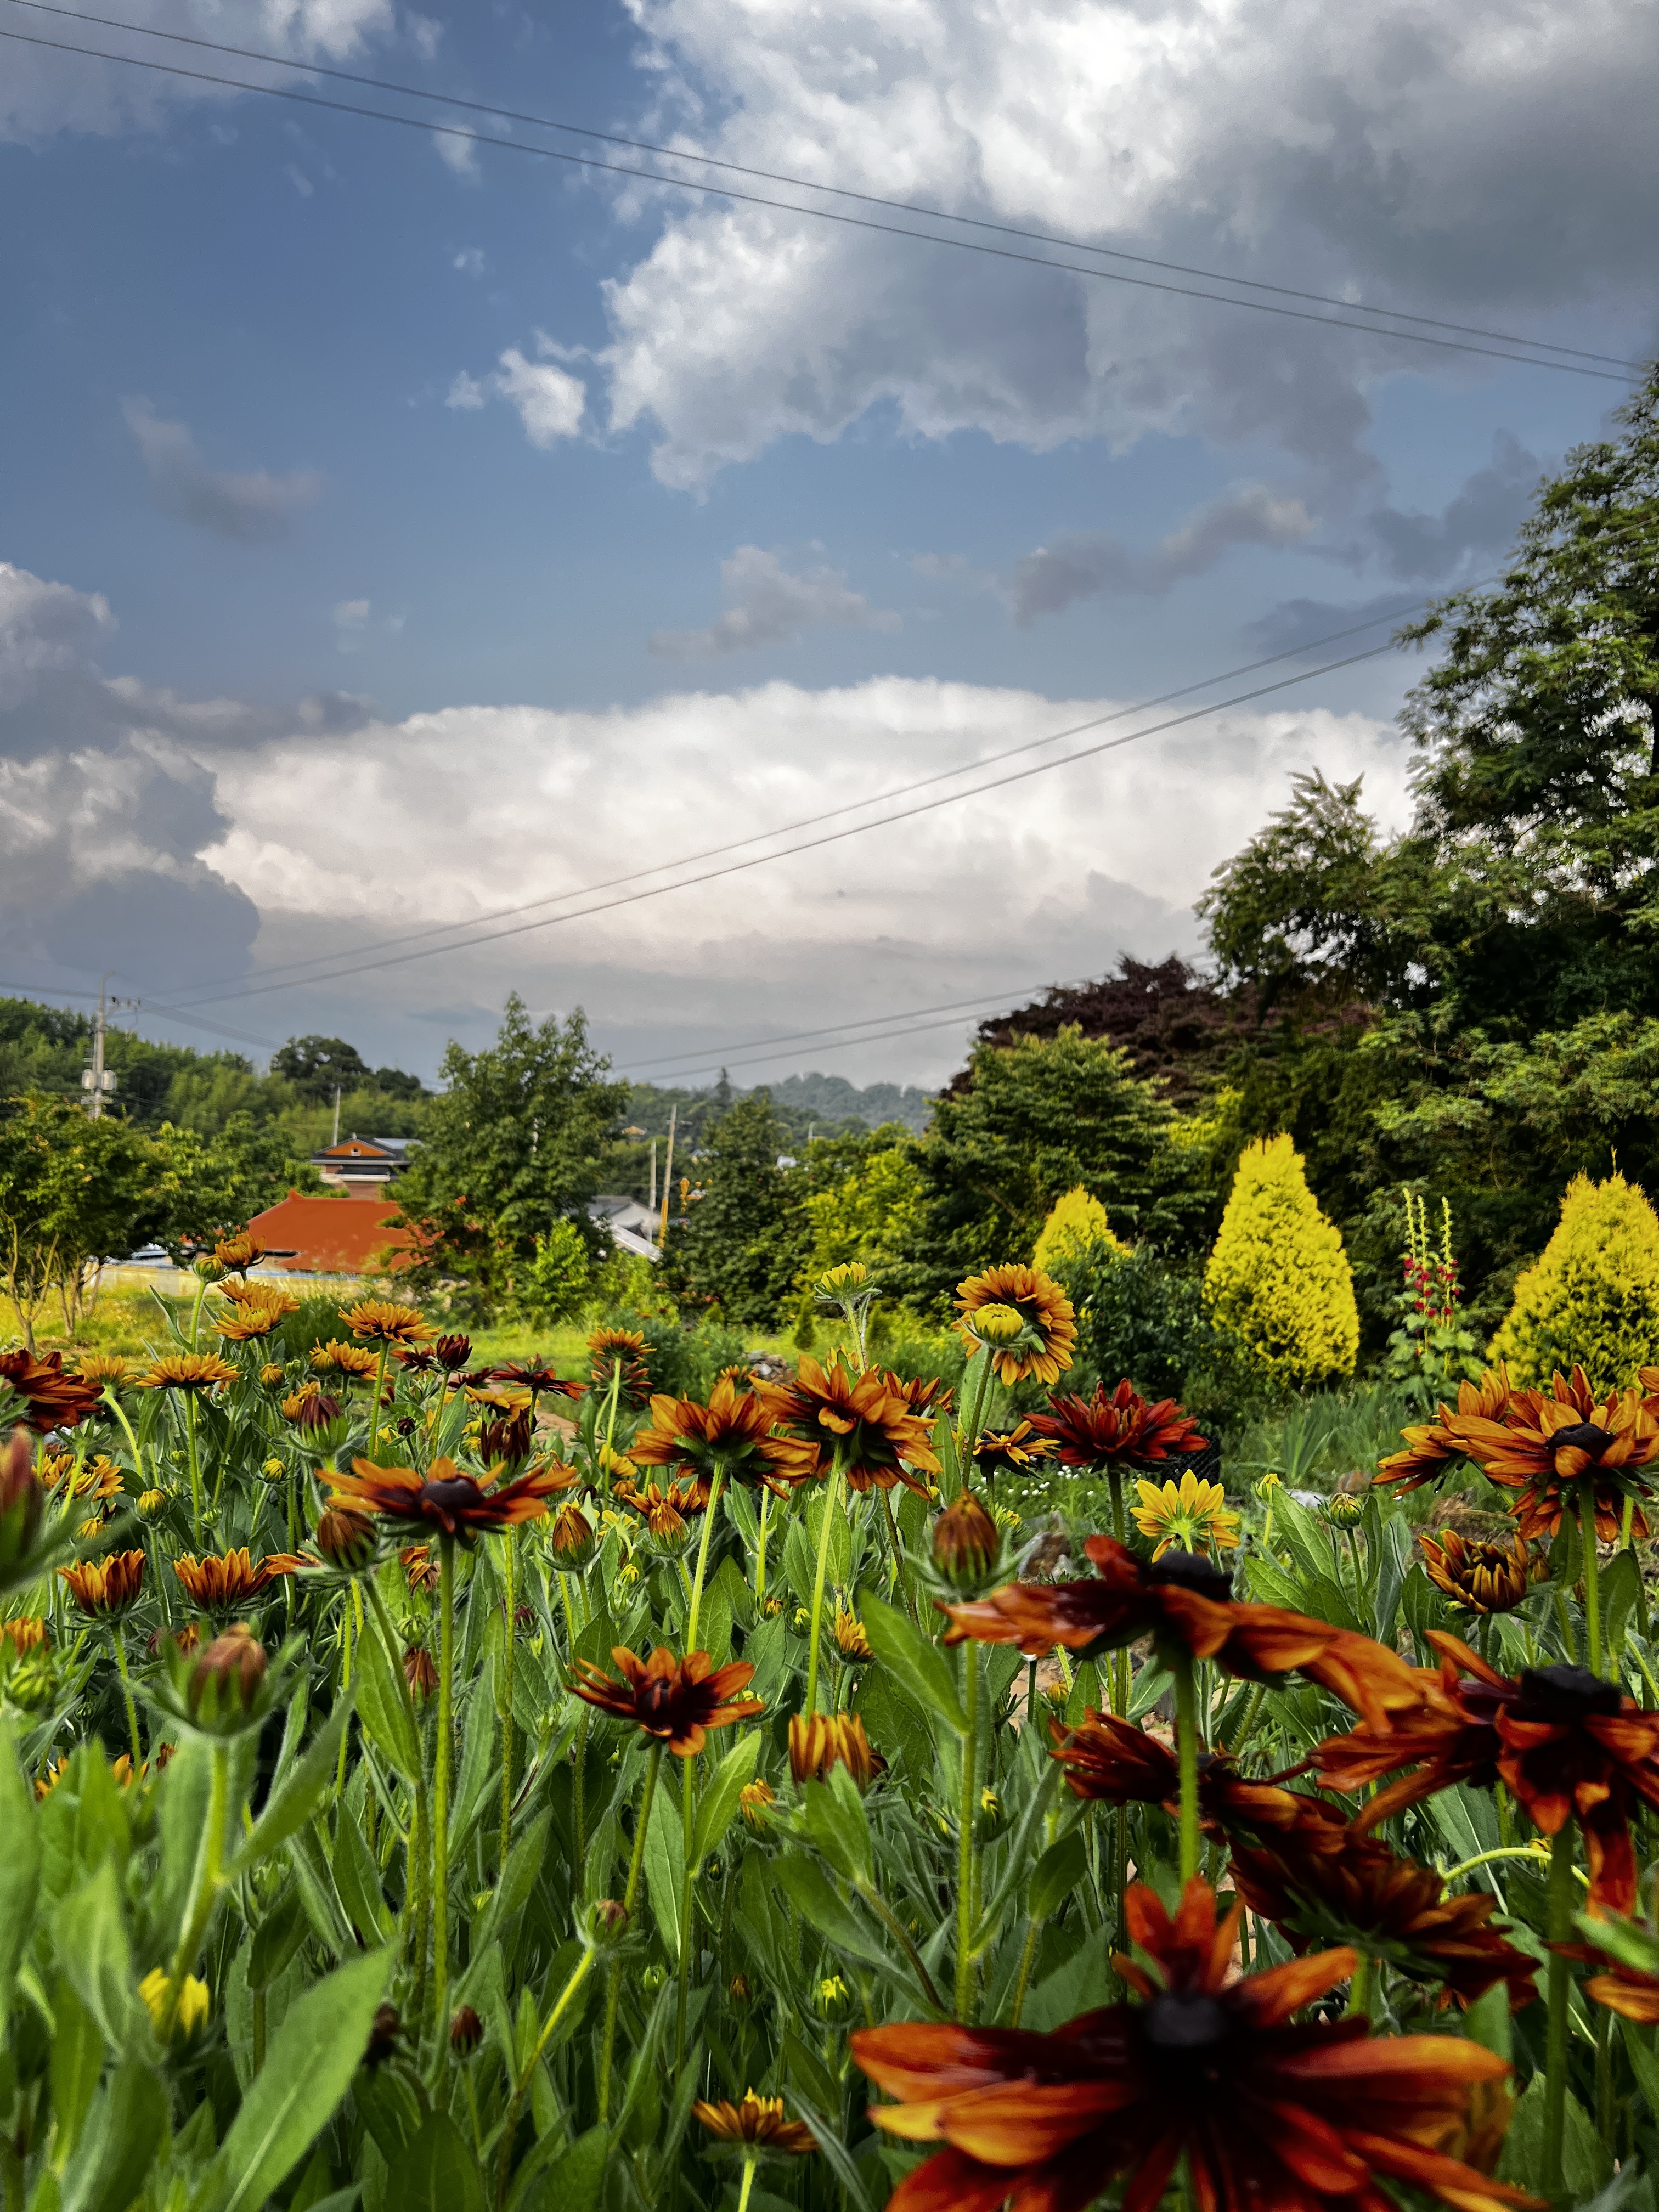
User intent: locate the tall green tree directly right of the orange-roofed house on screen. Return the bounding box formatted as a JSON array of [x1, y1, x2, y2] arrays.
[[396, 993, 628, 1312]]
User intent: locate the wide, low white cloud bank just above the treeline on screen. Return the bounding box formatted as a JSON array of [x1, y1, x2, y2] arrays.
[[198, 677, 1409, 1082]]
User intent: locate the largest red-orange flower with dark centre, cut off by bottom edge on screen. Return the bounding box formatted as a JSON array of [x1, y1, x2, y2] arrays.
[[849, 1878, 1535, 2212]]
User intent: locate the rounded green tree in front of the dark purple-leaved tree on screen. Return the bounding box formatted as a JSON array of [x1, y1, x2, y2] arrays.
[[905, 1029, 1203, 1303]]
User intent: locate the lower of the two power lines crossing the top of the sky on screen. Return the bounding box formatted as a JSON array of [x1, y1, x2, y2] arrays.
[[0, 19, 1644, 385]]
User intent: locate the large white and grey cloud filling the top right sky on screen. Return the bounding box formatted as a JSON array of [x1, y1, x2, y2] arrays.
[[608, 0, 1659, 487]]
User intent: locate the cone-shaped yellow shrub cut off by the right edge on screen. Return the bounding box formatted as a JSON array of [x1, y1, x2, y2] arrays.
[[1491, 1175, 1659, 1389]]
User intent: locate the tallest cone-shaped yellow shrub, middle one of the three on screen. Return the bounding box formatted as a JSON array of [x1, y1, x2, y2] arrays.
[[1203, 1137, 1361, 1389]]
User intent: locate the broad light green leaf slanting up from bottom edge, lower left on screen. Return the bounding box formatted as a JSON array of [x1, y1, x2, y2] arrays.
[[208, 1955, 392, 2212]]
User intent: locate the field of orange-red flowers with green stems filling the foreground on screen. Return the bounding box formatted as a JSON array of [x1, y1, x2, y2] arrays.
[[0, 1237, 1659, 2212]]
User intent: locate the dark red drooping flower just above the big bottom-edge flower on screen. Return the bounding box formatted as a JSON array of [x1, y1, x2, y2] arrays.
[[1232, 1820, 1537, 2013]]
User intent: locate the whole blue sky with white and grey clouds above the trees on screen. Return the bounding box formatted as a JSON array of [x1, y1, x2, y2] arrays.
[[0, 0, 1659, 1084]]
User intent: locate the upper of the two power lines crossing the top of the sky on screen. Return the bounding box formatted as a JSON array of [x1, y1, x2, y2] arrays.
[[0, 0, 1646, 374]]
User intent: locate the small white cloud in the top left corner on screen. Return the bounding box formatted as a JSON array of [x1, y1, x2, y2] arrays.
[[0, 0, 396, 144]]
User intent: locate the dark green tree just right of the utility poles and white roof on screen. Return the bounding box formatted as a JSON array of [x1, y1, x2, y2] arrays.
[[662, 1091, 805, 1327]]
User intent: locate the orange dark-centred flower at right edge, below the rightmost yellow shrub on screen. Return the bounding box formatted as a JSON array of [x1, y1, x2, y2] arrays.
[[1449, 1367, 1659, 1544]]
